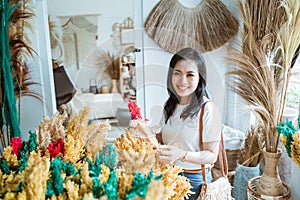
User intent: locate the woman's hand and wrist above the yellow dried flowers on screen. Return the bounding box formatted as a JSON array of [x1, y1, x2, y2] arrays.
[[157, 145, 186, 164]]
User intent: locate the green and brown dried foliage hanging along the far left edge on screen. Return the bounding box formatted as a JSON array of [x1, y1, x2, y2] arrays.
[[0, 0, 33, 151]]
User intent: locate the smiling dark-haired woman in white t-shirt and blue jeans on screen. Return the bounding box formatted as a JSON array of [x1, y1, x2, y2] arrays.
[[157, 48, 222, 200]]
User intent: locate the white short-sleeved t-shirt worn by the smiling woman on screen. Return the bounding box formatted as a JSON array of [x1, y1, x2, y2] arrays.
[[160, 102, 222, 169]]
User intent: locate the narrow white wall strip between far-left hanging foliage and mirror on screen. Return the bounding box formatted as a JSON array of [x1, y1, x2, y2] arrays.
[[18, 0, 56, 140]]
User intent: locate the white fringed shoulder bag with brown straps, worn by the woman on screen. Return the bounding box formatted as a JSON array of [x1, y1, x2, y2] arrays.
[[198, 103, 232, 200]]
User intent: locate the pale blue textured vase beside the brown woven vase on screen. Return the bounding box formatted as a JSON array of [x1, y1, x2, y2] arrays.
[[232, 163, 260, 200]]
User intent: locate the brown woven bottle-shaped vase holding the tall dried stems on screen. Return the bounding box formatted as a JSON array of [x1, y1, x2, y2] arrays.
[[257, 149, 284, 197]]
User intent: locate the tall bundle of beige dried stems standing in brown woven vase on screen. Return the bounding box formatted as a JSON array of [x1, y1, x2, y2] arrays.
[[228, 0, 300, 152]]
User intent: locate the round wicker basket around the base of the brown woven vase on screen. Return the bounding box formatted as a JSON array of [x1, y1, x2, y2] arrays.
[[247, 176, 291, 200]]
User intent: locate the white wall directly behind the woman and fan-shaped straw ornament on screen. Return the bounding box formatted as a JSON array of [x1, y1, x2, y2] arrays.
[[139, 0, 250, 130]]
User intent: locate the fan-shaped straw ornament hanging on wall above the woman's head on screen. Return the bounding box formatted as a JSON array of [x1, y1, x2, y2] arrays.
[[144, 0, 239, 53]]
